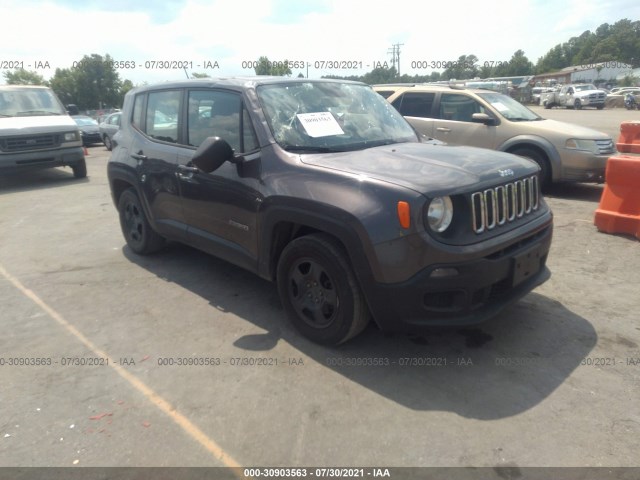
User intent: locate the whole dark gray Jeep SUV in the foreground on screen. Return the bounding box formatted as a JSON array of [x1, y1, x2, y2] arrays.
[[107, 77, 552, 344]]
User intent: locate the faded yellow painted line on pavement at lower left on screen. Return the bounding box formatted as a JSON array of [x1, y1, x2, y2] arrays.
[[0, 265, 245, 478]]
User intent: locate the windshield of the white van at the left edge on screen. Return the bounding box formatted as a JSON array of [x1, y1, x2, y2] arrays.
[[0, 87, 67, 117]]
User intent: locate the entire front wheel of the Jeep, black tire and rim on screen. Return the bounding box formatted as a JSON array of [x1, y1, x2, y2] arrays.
[[277, 234, 371, 345]]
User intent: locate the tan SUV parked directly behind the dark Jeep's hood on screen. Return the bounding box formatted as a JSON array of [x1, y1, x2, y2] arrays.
[[374, 85, 616, 186]]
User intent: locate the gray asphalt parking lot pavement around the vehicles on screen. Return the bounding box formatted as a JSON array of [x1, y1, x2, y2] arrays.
[[0, 107, 640, 472]]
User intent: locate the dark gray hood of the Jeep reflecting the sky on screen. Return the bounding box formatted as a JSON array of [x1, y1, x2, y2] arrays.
[[300, 143, 538, 194]]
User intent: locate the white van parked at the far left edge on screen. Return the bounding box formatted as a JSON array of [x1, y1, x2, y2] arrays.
[[0, 85, 87, 178]]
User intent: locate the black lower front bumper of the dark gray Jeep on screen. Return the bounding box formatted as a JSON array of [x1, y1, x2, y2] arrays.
[[367, 219, 552, 332]]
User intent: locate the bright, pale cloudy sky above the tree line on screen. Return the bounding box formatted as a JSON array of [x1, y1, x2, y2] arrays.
[[0, 0, 640, 84]]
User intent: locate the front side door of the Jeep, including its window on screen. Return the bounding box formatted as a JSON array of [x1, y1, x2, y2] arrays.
[[178, 89, 262, 271]]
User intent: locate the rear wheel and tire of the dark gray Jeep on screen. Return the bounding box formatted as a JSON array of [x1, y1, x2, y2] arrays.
[[118, 188, 165, 255]]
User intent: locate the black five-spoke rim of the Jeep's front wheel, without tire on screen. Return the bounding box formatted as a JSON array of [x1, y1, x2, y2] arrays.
[[288, 258, 339, 328]]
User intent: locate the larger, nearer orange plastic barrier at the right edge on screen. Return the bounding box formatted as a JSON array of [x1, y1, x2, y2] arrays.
[[593, 155, 640, 239]]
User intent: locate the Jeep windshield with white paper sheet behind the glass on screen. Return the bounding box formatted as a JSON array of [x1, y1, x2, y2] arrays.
[[257, 81, 419, 153]]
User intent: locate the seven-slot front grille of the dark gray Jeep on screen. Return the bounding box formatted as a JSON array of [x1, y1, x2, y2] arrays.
[[471, 175, 540, 233]]
